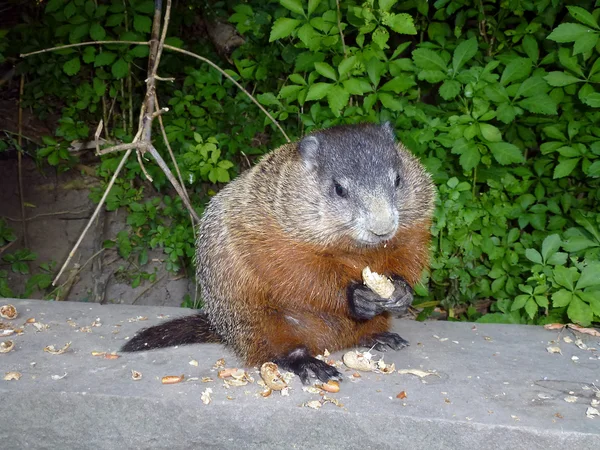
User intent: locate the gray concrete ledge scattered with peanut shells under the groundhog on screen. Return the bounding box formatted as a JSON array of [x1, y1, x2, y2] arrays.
[[0, 299, 600, 450]]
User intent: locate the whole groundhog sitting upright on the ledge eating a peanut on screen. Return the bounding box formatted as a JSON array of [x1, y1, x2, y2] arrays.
[[122, 123, 435, 383]]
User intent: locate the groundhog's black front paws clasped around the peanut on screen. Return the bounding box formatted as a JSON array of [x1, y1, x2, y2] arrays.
[[347, 276, 413, 320]]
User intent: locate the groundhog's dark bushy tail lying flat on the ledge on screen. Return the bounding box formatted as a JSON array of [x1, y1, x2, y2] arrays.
[[121, 313, 221, 352]]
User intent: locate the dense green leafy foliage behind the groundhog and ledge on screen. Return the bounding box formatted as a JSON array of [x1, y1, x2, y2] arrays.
[[0, 0, 600, 325]]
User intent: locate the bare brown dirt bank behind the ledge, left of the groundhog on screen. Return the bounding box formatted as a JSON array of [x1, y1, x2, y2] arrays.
[[0, 157, 194, 306]]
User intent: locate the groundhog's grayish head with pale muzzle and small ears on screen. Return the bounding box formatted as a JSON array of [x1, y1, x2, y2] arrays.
[[298, 123, 433, 246]]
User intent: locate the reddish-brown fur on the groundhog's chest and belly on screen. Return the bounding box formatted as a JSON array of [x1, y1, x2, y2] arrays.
[[223, 219, 430, 364]]
